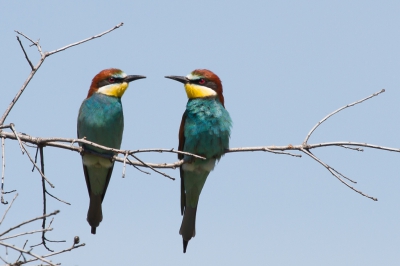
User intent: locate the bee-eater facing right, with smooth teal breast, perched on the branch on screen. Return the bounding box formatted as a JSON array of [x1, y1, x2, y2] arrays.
[[78, 68, 145, 234]]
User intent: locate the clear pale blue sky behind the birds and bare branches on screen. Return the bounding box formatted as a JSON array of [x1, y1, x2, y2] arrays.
[[0, 0, 400, 266]]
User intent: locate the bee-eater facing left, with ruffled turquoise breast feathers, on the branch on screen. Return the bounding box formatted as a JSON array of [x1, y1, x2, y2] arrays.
[[166, 69, 232, 253]]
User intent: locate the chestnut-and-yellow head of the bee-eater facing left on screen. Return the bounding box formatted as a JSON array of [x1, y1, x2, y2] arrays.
[[165, 69, 224, 105]]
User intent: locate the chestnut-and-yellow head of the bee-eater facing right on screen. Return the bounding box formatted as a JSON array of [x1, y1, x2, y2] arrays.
[[87, 68, 146, 98]]
